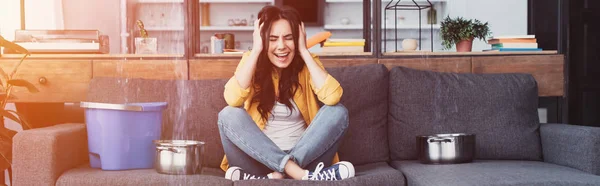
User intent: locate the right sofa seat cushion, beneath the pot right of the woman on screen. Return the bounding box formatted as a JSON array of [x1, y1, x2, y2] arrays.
[[391, 160, 600, 186]]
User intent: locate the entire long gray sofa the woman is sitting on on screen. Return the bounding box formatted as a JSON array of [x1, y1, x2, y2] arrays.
[[13, 64, 600, 185]]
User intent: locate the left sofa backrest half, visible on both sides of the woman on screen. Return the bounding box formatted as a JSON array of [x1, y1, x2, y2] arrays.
[[87, 65, 389, 168]]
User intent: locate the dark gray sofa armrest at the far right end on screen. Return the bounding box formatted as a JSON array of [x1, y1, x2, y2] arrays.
[[540, 124, 600, 175]]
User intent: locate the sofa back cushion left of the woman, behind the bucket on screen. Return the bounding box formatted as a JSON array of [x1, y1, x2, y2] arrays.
[[87, 78, 227, 168]]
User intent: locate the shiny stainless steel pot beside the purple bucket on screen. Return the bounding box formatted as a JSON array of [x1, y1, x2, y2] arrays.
[[154, 140, 204, 174]]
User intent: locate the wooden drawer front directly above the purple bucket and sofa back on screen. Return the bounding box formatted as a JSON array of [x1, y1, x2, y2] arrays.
[[92, 59, 188, 79]]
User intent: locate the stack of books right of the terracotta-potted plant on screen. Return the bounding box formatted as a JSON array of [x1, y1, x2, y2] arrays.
[[484, 35, 542, 52]]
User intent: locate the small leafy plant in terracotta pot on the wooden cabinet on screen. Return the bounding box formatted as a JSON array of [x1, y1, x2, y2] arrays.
[[440, 16, 491, 52]]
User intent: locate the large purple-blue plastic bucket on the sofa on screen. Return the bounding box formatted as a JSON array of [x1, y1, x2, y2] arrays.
[[81, 102, 167, 170]]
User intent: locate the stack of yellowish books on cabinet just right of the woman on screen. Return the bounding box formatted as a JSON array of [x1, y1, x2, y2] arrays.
[[321, 39, 365, 53]]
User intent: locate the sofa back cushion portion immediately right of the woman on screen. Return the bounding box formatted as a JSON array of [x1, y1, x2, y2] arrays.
[[327, 64, 389, 165]]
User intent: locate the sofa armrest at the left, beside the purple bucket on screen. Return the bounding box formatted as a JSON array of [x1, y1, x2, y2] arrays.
[[12, 123, 89, 185]]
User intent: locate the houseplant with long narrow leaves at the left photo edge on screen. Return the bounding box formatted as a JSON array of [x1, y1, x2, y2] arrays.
[[0, 36, 39, 184]]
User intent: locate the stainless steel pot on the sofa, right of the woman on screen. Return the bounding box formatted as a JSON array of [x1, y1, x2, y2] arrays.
[[417, 133, 475, 164]]
